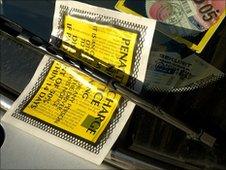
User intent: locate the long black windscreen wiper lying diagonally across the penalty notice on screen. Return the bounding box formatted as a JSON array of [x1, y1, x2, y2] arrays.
[[0, 16, 216, 147]]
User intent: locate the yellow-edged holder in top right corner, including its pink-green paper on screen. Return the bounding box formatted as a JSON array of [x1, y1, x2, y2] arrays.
[[115, 0, 226, 53]]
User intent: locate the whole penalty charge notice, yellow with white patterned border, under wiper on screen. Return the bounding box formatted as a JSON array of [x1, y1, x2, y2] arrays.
[[3, 1, 155, 164]]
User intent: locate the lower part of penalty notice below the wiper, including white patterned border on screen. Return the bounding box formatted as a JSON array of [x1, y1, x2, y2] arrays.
[[2, 56, 131, 164]]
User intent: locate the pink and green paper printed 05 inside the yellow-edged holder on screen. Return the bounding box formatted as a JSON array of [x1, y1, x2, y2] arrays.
[[146, 0, 225, 31]]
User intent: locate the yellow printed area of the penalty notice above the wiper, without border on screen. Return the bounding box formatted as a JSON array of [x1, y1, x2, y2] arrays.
[[61, 16, 137, 83]]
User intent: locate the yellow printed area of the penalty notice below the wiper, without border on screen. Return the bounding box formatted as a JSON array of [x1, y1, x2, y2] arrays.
[[23, 61, 120, 143]]
